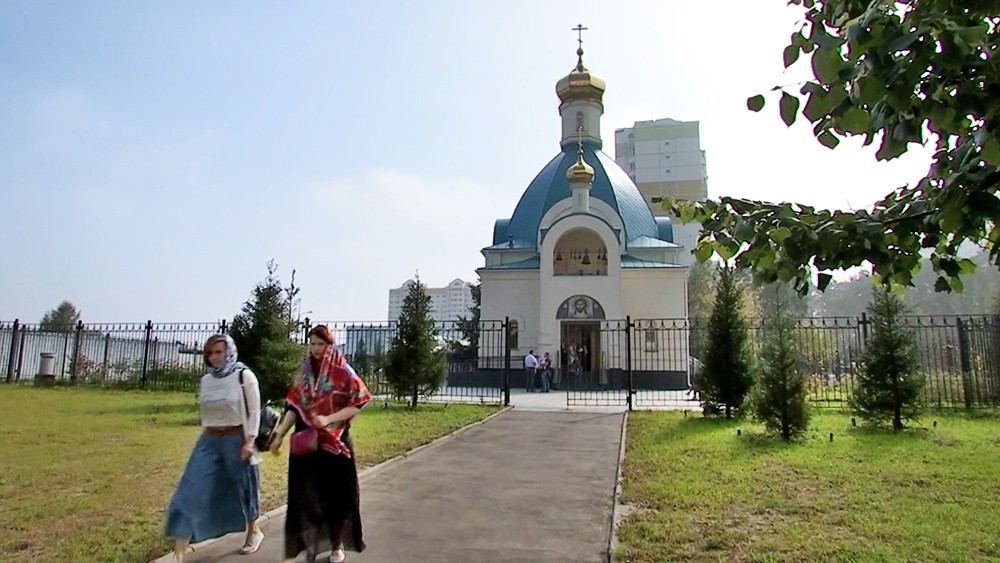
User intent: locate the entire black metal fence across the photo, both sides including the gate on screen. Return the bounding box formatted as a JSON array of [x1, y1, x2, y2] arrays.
[[0, 315, 1000, 409]]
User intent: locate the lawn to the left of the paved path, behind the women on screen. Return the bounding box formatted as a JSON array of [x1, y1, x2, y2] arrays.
[[0, 386, 497, 562]]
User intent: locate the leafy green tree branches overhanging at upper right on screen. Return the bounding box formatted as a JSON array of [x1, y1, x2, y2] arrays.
[[663, 0, 1000, 293]]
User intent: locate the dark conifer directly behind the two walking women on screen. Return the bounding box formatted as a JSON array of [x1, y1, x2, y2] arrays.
[[229, 260, 305, 401]]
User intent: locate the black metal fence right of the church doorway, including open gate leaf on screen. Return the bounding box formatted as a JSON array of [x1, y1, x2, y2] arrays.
[[554, 315, 1000, 409]]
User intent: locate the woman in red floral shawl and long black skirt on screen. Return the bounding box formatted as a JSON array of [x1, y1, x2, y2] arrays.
[[270, 325, 371, 563]]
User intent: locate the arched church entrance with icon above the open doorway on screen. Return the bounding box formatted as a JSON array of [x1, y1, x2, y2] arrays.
[[553, 295, 606, 389]]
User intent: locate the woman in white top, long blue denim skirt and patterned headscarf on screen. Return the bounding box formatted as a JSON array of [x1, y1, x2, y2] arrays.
[[165, 334, 264, 562]]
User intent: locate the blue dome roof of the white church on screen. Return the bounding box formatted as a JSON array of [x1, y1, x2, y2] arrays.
[[493, 143, 673, 246]]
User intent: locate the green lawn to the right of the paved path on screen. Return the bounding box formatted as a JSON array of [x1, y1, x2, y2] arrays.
[[617, 412, 1000, 562]]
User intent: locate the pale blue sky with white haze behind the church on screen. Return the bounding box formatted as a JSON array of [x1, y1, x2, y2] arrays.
[[0, 0, 927, 322]]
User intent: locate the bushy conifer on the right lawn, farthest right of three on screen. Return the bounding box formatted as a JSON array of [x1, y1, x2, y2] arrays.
[[850, 288, 924, 430]]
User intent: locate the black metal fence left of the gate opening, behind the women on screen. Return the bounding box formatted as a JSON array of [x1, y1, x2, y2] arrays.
[[0, 319, 509, 404]]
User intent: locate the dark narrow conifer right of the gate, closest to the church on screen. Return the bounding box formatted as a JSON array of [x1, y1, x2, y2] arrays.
[[698, 265, 753, 418]]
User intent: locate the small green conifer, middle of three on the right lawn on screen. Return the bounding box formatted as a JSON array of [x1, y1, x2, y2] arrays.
[[752, 294, 809, 441]]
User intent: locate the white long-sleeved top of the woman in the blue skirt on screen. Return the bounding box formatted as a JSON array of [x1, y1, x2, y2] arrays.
[[198, 368, 260, 465]]
